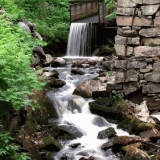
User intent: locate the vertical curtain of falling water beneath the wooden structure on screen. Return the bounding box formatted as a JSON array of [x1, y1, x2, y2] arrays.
[[66, 23, 97, 57]]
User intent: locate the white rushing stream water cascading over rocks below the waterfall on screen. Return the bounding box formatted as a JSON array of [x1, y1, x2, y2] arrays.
[[48, 57, 128, 160]]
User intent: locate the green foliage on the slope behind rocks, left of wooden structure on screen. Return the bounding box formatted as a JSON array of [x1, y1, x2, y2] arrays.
[[0, 0, 69, 42]]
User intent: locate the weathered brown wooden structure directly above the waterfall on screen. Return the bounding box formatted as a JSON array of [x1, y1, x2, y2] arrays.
[[69, 0, 106, 23]]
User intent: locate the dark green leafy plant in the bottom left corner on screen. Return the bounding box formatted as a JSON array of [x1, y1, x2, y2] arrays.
[[0, 126, 31, 160]]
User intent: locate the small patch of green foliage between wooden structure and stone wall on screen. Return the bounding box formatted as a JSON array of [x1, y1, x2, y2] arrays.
[[104, 0, 116, 21]]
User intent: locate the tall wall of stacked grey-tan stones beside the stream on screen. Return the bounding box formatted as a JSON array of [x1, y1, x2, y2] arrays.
[[103, 0, 160, 102]]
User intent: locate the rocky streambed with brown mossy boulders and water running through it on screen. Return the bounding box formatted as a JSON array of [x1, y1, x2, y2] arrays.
[[13, 54, 160, 160]]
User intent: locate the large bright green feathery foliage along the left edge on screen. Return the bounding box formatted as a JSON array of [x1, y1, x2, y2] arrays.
[[0, 15, 44, 115]]
